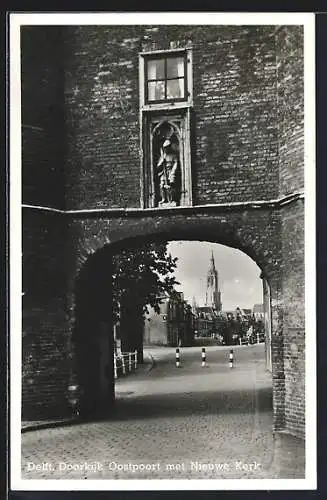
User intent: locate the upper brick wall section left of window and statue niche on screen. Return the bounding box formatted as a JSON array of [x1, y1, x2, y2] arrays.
[[65, 26, 140, 208]]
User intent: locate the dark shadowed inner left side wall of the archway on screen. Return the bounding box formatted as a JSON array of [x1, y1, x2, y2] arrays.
[[72, 249, 114, 418]]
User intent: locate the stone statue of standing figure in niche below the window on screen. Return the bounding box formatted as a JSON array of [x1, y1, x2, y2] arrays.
[[157, 139, 179, 206]]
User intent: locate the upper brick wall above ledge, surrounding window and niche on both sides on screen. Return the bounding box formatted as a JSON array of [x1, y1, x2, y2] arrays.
[[65, 26, 278, 208]]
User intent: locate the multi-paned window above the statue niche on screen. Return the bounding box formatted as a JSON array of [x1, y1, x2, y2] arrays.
[[145, 53, 187, 103]]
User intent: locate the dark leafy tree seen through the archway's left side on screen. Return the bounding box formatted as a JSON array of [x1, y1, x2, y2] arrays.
[[112, 242, 178, 362]]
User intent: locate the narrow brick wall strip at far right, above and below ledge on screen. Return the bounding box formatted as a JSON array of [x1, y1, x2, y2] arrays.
[[276, 26, 305, 436]]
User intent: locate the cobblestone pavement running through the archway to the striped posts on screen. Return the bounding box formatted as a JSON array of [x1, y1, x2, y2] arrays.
[[22, 345, 304, 479]]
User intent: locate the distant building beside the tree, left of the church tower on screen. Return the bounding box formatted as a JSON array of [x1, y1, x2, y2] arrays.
[[143, 292, 194, 347]]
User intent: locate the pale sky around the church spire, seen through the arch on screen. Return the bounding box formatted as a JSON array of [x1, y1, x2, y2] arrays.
[[168, 241, 262, 311]]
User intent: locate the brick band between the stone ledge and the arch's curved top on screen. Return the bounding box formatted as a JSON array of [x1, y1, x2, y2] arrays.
[[69, 207, 281, 279]]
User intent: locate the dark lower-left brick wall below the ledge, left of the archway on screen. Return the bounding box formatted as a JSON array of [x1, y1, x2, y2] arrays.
[[22, 211, 70, 419]]
